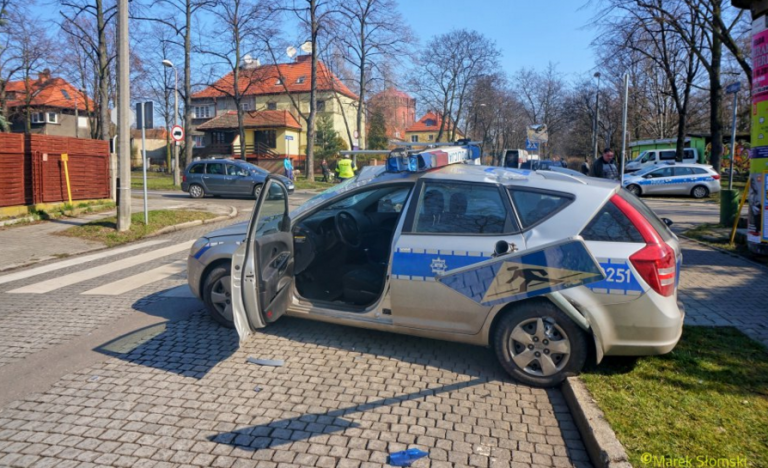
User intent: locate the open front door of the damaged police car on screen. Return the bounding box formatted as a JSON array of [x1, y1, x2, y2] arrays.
[[232, 177, 293, 341]]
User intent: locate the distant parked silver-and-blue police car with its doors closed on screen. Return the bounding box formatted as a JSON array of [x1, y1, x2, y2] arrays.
[[624, 163, 720, 198]]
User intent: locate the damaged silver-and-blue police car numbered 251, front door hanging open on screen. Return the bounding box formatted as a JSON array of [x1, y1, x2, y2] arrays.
[[188, 145, 684, 387]]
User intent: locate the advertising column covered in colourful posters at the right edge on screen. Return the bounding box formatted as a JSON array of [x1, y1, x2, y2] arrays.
[[747, 15, 768, 254]]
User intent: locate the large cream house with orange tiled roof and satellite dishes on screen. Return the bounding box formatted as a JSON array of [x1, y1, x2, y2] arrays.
[[192, 55, 364, 158]]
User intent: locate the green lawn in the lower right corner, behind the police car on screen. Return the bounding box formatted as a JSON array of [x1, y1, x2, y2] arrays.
[[581, 327, 768, 467]]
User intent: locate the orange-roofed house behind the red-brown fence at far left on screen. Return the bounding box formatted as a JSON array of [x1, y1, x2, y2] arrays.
[[5, 70, 95, 138]]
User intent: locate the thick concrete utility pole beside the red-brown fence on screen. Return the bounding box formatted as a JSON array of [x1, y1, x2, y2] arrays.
[[115, 0, 131, 231]]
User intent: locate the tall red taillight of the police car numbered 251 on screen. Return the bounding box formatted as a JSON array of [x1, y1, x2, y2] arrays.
[[611, 195, 677, 297]]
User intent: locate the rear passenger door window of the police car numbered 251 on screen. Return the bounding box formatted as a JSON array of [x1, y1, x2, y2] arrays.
[[413, 182, 516, 234]]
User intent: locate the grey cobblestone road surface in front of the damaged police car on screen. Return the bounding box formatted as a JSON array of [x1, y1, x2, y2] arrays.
[[0, 196, 590, 468]]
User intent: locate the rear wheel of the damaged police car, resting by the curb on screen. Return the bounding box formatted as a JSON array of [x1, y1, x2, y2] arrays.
[[493, 300, 587, 388]]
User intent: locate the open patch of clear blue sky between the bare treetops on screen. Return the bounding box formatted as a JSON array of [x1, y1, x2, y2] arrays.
[[398, 0, 597, 79]]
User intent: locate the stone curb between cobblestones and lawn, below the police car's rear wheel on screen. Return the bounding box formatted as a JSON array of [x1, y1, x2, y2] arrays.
[[560, 377, 632, 468]]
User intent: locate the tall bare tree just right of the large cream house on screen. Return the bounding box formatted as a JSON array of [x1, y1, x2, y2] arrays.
[[334, 0, 415, 148]]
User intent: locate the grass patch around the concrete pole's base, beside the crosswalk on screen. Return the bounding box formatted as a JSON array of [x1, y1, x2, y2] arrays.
[[57, 210, 216, 247]]
